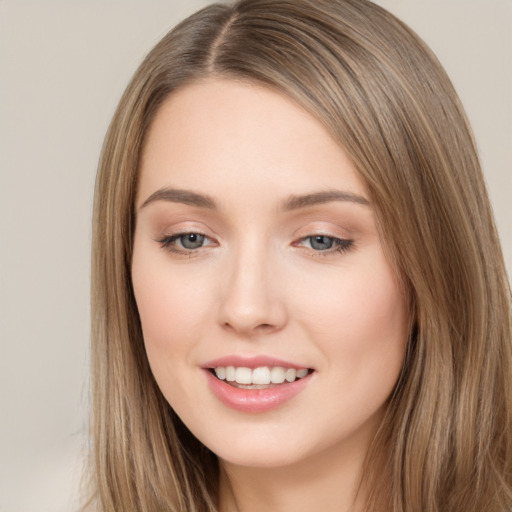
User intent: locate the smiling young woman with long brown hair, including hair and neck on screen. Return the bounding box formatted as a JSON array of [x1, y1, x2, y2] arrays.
[[86, 0, 512, 512]]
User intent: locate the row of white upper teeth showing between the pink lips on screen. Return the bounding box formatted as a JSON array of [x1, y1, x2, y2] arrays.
[[214, 366, 309, 385]]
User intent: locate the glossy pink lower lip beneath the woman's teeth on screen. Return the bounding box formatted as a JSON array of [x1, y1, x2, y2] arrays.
[[205, 370, 311, 413]]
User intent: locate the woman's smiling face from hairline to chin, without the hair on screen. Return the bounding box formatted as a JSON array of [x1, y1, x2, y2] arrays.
[[132, 79, 408, 467]]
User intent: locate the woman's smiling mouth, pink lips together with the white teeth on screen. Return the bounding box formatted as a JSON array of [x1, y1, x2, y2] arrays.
[[203, 356, 314, 413]]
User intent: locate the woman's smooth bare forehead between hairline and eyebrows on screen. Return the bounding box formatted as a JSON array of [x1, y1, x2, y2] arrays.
[[139, 79, 365, 206]]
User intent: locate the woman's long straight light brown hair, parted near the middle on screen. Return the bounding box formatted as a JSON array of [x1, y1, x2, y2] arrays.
[[91, 0, 512, 512]]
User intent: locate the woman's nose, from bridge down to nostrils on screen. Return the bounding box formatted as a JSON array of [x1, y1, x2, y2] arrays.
[[219, 243, 288, 338]]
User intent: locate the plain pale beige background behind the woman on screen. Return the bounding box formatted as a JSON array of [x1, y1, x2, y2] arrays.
[[0, 0, 512, 512]]
